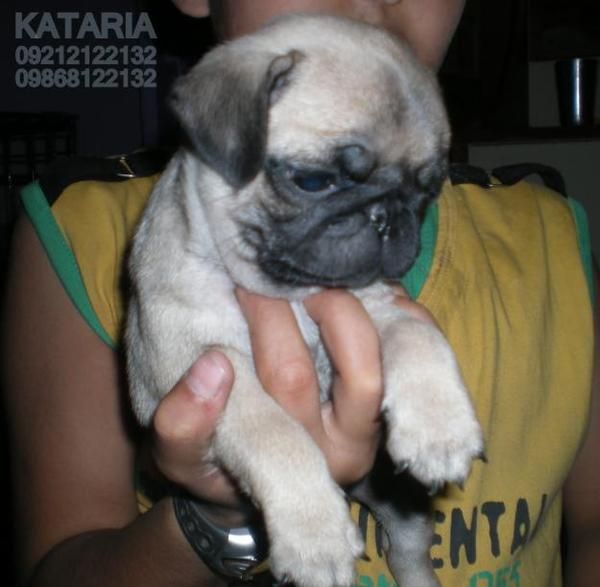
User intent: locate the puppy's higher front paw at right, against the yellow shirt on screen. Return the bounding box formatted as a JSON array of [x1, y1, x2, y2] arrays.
[[383, 326, 484, 491]]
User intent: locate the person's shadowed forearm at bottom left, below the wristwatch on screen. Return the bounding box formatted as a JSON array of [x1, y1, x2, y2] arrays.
[[29, 500, 225, 587]]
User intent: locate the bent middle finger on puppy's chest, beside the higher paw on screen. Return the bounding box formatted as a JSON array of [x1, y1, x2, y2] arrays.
[[304, 290, 383, 442]]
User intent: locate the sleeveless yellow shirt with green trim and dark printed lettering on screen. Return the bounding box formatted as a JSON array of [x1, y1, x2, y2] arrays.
[[24, 168, 593, 587]]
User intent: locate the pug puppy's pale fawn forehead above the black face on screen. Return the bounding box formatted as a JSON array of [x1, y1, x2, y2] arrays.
[[268, 19, 449, 163]]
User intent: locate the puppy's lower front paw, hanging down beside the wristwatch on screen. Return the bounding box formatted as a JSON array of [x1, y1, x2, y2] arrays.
[[265, 484, 364, 587]]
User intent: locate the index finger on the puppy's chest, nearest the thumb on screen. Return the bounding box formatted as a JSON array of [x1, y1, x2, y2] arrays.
[[236, 288, 322, 435]]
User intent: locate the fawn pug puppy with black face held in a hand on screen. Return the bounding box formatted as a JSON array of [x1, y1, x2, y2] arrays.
[[126, 15, 483, 587]]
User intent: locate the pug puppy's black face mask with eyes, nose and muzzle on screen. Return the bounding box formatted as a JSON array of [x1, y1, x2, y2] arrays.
[[252, 154, 439, 287]]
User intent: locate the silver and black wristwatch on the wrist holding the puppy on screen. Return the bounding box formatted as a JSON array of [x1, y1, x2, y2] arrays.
[[173, 495, 268, 581]]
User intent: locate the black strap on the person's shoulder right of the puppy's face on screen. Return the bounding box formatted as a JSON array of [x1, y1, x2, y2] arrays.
[[450, 163, 567, 197]]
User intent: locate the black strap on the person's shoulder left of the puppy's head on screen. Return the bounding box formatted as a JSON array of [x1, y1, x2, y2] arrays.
[[39, 149, 173, 204]]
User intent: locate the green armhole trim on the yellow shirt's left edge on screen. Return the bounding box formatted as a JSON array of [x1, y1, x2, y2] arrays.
[[21, 181, 115, 348]]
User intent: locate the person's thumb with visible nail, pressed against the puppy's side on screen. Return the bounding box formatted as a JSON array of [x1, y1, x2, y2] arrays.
[[153, 351, 234, 501]]
